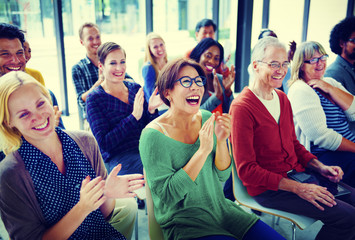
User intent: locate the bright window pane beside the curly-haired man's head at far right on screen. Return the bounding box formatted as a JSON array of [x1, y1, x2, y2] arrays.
[[307, 0, 348, 65]]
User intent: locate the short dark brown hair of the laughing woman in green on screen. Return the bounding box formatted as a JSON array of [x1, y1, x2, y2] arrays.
[[157, 58, 206, 106]]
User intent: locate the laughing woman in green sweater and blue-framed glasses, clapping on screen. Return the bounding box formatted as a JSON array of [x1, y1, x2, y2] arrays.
[[139, 59, 284, 240]]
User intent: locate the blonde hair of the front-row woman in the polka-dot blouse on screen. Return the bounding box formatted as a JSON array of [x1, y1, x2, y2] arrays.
[[0, 71, 52, 155]]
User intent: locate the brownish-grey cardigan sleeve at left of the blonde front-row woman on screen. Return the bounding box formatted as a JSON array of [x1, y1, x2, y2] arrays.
[[0, 154, 46, 240]]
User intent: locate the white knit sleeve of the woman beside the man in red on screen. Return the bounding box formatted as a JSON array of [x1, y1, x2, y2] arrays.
[[288, 80, 342, 151]]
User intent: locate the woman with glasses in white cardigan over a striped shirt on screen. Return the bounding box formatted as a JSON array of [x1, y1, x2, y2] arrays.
[[288, 41, 355, 187]]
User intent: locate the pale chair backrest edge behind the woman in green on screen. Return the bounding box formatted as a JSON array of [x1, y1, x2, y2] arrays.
[[143, 170, 164, 240]]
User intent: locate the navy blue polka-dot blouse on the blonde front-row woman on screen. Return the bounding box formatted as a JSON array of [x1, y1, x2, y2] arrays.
[[18, 128, 126, 239]]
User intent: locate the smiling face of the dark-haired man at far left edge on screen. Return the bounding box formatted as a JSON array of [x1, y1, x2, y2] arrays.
[[0, 38, 26, 76]]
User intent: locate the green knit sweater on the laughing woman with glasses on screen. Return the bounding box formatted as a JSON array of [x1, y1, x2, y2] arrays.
[[139, 110, 257, 240]]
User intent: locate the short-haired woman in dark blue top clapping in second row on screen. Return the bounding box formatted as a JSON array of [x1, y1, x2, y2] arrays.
[[86, 42, 162, 174]]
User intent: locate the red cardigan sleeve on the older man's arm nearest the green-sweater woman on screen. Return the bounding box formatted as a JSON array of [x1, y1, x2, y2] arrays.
[[230, 103, 282, 194]]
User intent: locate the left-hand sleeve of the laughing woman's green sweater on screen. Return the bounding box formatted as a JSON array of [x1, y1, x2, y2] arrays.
[[139, 128, 197, 206]]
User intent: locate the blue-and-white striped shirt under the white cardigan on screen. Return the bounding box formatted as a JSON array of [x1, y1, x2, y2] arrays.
[[311, 89, 355, 154]]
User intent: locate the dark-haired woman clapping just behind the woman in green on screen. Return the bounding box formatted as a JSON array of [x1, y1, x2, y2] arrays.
[[190, 38, 235, 113]]
